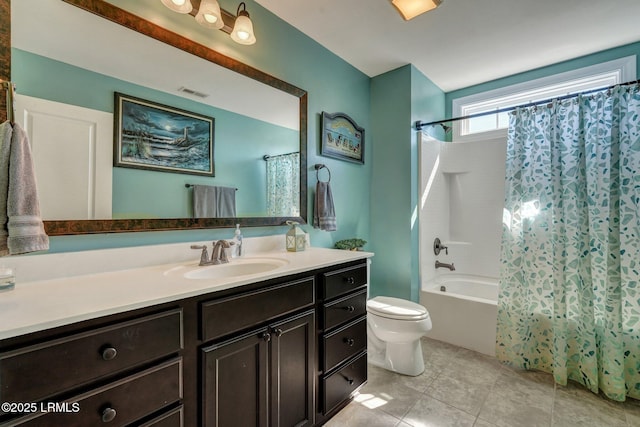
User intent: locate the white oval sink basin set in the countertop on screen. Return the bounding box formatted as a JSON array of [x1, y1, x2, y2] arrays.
[[164, 258, 289, 280]]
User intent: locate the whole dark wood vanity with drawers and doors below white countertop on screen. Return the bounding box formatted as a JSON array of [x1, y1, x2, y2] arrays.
[[0, 259, 367, 427]]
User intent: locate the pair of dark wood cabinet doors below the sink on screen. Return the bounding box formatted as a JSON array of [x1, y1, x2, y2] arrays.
[[202, 311, 315, 427]]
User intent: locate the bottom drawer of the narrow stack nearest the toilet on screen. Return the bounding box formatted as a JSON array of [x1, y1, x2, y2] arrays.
[[322, 353, 367, 414]]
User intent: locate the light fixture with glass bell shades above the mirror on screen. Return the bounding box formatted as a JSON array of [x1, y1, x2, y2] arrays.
[[160, 0, 256, 45]]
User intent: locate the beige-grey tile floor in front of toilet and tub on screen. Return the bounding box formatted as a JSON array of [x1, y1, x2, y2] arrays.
[[326, 338, 640, 427]]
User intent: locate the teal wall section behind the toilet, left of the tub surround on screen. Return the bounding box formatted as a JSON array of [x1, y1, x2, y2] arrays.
[[370, 65, 444, 301]]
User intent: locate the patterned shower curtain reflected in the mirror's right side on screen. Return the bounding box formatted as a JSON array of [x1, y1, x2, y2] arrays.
[[267, 153, 300, 216]]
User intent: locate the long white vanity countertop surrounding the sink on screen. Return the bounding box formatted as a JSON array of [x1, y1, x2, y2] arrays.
[[0, 239, 373, 339]]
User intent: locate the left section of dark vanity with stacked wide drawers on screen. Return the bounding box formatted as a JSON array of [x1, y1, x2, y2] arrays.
[[0, 308, 183, 426]]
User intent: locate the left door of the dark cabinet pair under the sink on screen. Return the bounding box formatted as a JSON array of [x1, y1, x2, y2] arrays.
[[202, 331, 270, 427]]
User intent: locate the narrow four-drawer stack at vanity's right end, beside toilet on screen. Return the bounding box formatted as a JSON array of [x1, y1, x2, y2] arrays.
[[317, 260, 368, 423]]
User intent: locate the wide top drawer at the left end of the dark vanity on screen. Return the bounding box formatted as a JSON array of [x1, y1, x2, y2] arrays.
[[0, 309, 183, 402]]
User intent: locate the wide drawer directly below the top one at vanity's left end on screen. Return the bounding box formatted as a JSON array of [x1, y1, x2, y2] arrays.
[[9, 358, 182, 427]]
